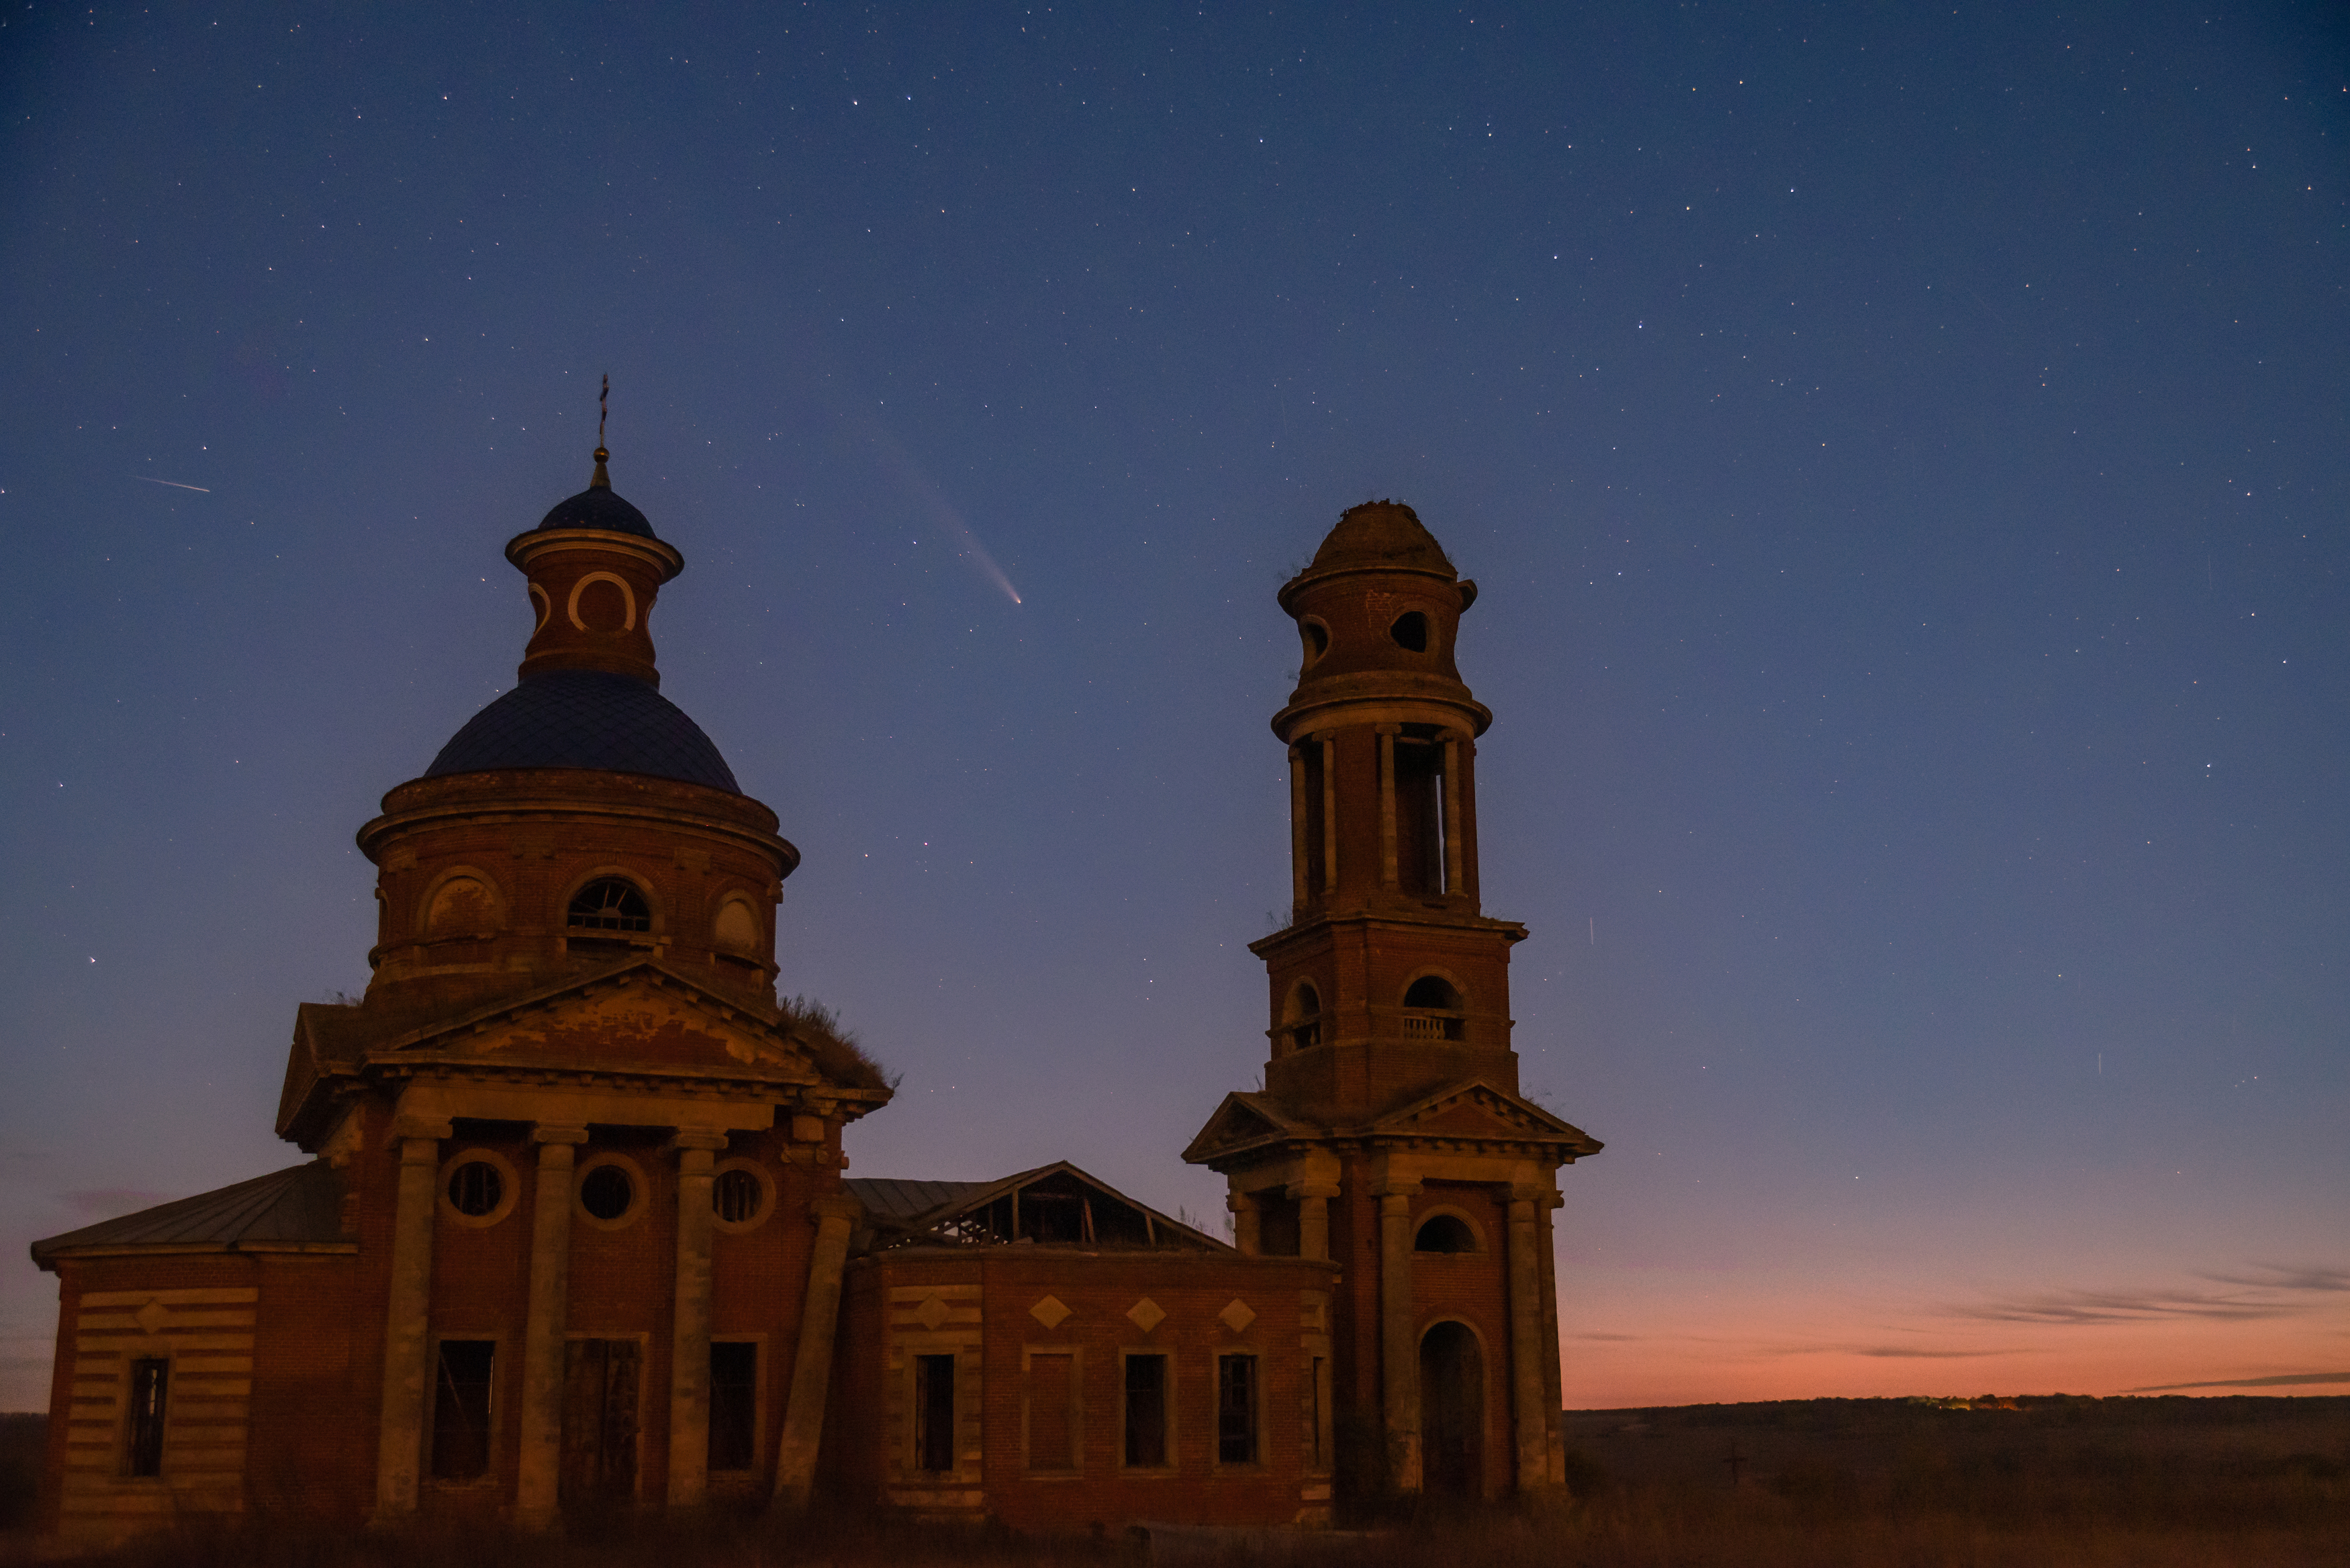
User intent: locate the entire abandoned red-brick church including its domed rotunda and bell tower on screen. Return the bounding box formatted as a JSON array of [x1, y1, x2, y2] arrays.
[[33, 446, 1601, 1542]]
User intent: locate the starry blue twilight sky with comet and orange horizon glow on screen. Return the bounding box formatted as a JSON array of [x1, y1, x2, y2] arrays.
[[0, 0, 2350, 1408]]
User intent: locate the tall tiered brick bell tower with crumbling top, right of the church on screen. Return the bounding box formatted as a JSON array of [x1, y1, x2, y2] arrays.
[[1184, 501, 1601, 1498]]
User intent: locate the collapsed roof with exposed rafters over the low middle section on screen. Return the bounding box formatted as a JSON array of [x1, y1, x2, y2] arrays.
[[841, 1159, 1234, 1253]]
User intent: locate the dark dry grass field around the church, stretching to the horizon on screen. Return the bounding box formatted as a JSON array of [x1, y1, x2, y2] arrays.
[[0, 1396, 2350, 1568]]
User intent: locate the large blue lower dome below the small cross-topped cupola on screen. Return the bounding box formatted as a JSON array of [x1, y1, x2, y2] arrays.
[[426, 667, 743, 795]]
